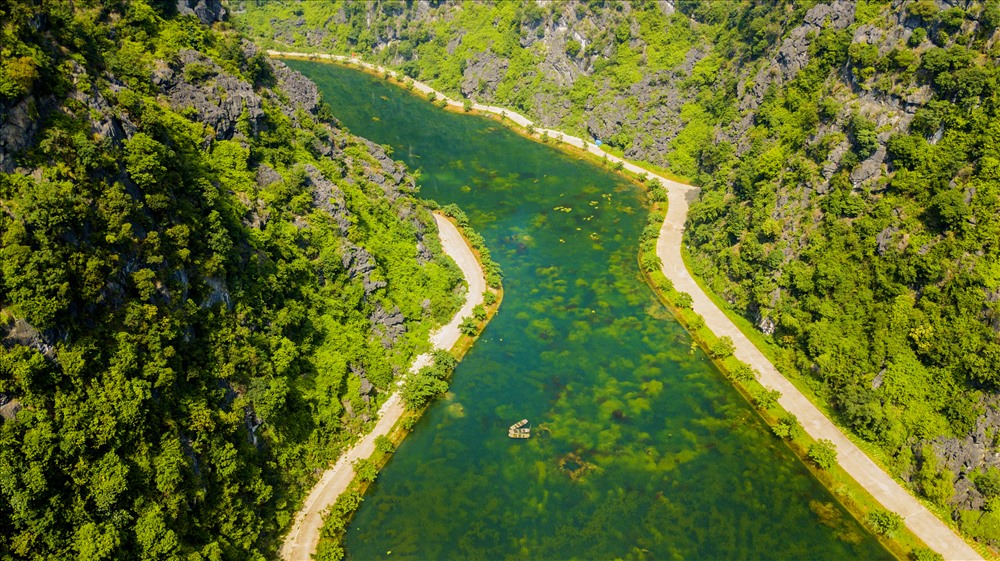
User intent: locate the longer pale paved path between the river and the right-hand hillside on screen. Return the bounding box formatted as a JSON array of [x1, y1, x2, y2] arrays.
[[271, 52, 981, 559]]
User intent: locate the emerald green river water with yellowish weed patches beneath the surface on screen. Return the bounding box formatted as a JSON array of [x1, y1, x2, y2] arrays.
[[289, 62, 891, 561]]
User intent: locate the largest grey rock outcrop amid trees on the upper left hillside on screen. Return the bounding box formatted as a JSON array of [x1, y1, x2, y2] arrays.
[[153, 50, 264, 140]]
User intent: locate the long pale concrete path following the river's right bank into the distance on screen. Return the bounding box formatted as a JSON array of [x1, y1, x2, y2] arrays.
[[267, 50, 983, 560]]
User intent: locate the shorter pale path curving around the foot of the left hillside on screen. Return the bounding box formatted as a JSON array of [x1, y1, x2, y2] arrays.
[[281, 212, 501, 561]]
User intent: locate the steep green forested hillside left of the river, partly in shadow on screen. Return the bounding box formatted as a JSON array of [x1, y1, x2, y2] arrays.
[[0, 0, 462, 560]]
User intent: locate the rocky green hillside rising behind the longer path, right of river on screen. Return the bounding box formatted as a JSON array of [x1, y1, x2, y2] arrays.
[[233, 0, 1000, 545]]
